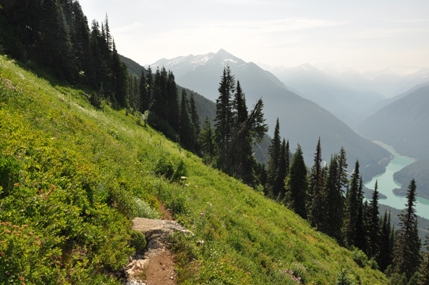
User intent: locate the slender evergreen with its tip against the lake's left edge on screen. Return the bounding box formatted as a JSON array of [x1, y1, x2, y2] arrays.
[[367, 181, 381, 260]]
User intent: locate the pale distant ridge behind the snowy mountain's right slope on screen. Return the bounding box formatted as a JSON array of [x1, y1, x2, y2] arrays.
[[273, 63, 384, 127]]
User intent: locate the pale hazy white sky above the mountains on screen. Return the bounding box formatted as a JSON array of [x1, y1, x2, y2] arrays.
[[79, 0, 429, 71]]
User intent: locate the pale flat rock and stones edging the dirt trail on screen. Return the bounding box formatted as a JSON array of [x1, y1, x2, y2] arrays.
[[124, 218, 193, 285]]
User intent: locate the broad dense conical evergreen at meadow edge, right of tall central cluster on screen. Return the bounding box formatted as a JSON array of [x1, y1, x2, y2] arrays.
[[285, 144, 308, 219]]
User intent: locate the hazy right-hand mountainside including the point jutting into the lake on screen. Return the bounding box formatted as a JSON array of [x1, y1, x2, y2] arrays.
[[358, 83, 429, 199]]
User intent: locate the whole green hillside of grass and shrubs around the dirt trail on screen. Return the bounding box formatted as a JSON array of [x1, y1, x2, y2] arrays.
[[0, 56, 387, 284]]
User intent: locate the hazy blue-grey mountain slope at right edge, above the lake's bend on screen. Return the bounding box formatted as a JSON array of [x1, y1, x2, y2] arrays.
[[358, 85, 429, 159]]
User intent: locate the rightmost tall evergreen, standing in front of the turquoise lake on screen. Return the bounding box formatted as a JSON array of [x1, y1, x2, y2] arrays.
[[393, 179, 421, 280]]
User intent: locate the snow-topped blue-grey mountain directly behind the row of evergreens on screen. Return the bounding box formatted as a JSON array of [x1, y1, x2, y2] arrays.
[[151, 50, 390, 179]]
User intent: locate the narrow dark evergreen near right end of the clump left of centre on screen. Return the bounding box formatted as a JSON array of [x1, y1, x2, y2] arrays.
[[179, 89, 196, 151]]
